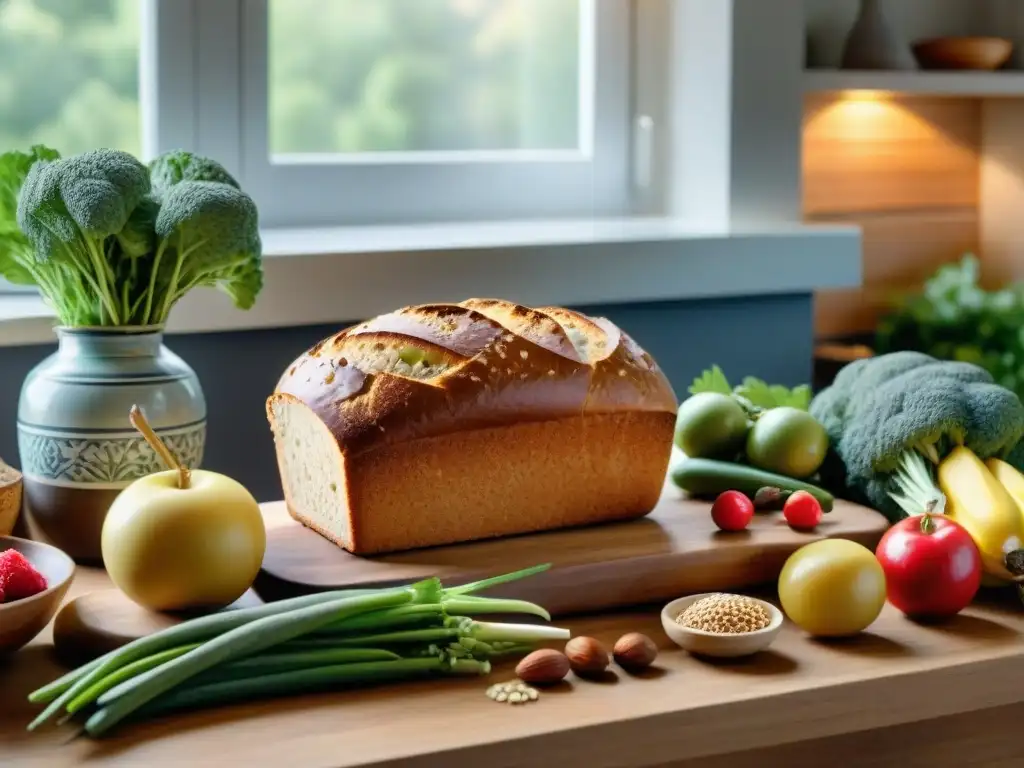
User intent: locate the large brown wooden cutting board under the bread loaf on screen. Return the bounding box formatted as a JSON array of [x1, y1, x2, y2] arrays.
[[261, 485, 887, 615]]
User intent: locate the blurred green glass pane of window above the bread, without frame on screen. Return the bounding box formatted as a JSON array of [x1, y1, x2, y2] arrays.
[[268, 0, 593, 156]]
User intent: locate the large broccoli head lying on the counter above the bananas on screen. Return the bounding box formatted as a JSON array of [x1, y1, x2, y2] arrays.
[[811, 352, 1024, 520]]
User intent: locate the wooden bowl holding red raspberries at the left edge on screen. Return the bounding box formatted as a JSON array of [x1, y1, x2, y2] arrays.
[[0, 536, 75, 655]]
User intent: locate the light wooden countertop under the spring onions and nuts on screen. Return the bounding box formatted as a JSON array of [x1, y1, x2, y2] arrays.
[[6, 569, 1024, 768]]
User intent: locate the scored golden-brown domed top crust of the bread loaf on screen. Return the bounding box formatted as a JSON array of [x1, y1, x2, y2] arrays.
[[267, 299, 678, 457]]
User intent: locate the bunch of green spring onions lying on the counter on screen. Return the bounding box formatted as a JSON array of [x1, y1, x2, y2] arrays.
[[29, 565, 569, 736]]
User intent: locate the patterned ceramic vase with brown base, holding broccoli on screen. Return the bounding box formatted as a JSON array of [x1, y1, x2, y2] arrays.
[[17, 327, 206, 562]]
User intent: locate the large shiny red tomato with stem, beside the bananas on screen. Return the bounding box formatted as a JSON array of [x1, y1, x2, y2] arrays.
[[874, 515, 982, 618]]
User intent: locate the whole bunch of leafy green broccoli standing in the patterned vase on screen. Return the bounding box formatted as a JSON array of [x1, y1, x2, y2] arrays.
[[0, 146, 263, 326]]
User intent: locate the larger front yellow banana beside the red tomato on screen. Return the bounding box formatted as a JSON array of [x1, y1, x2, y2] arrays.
[[938, 446, 1024, 581]]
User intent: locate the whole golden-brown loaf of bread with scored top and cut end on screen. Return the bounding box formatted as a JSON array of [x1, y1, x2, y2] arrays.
[[266, 299, 678, 554]]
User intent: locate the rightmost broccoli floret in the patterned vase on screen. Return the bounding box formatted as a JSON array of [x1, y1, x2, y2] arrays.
[[154, 181, 262, 323]]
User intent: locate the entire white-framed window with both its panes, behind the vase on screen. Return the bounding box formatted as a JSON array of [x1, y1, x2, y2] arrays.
[[0, 0, 630, 234]]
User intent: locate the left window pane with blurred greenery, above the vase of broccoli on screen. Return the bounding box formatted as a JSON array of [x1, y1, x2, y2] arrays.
[[0, 0, 141, 154]]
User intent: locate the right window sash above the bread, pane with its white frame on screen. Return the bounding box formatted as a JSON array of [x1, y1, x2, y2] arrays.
[[236, 0, 630, 225]]
